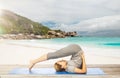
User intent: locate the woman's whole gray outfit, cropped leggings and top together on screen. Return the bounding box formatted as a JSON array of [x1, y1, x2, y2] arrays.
[[47, 44, 83, 73]]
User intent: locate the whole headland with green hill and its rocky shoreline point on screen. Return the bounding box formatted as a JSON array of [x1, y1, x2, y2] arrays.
[[0, 10, 77, 40]]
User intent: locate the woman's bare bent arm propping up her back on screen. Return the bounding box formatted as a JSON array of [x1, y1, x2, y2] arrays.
[[74, 54, 87, 74]]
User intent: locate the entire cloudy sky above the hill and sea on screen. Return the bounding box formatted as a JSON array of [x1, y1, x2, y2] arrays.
[[0, 0, 120, 36]]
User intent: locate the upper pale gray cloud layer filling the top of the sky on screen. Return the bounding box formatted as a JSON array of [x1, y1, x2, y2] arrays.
[[0, 0, 120, 24]]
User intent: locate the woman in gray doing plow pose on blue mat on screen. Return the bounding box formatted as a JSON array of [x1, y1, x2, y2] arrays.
[[29, 44, 87, 73]]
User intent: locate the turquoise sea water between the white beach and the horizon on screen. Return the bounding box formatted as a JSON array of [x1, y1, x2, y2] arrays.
[[8, 37, 120, 48]]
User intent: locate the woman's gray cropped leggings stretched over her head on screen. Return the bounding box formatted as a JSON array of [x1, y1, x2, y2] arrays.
[[47, 44, 82, 59]]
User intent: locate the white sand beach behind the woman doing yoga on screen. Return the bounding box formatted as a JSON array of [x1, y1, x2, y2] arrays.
[[0, 40, 120, 65]]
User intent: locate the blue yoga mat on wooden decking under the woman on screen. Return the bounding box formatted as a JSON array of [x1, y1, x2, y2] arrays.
[[9, 68, 105, 75]]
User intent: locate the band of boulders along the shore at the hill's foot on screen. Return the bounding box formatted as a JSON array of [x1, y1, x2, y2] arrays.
[[0, 30, 77, 40]]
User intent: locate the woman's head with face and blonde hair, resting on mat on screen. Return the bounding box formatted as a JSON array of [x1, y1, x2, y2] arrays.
[[54, 60, 67, 71]]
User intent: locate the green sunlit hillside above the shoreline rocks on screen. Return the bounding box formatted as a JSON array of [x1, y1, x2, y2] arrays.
[[0, 10, 50, 35]]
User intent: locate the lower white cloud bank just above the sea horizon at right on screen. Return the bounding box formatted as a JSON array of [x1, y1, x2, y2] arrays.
[[53, 15, 120, 36]]
